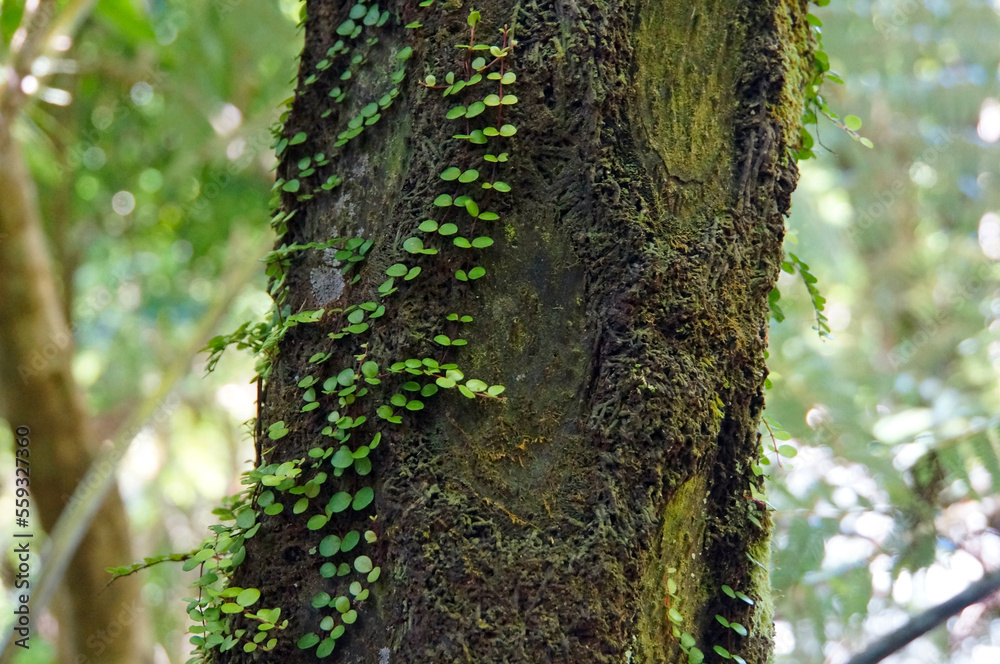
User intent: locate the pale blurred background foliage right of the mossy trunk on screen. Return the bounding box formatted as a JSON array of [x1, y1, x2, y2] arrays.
[[765, 0, 1000, 664]]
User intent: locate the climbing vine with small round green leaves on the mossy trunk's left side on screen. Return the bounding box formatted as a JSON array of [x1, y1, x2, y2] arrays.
[[109, 0, 518, 664]]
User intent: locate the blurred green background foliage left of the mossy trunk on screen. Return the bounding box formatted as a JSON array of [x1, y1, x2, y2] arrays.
[[0, 0, 301, 664]]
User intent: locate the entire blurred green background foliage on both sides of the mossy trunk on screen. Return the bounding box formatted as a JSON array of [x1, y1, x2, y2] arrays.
[[0, 0, 1000, 664]]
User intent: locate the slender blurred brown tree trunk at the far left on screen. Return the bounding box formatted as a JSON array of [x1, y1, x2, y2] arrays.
[[0, 7, 152, 664]]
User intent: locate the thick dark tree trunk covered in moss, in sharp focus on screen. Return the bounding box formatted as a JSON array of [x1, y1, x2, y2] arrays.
[[223, 0, 810, 664]]
